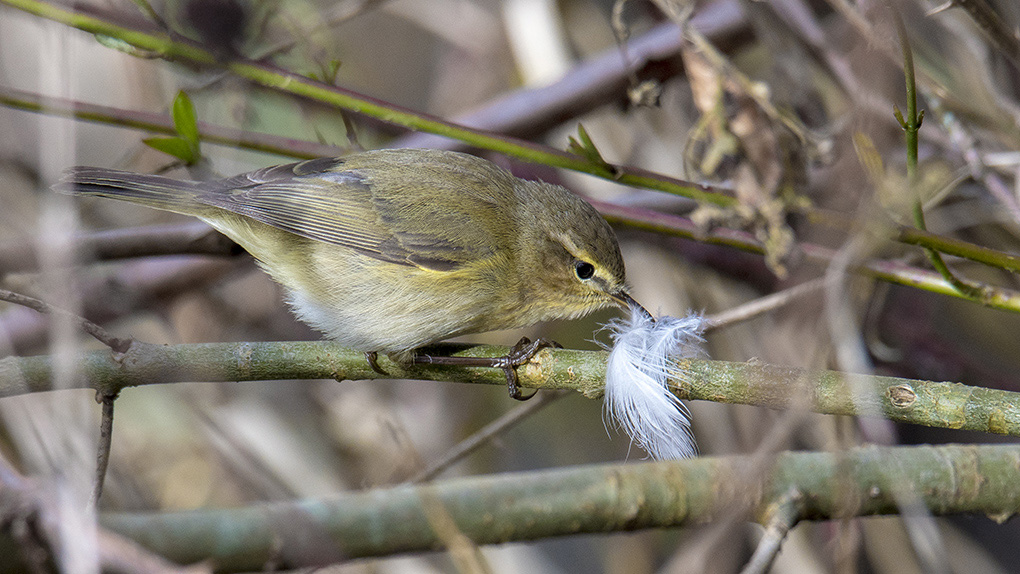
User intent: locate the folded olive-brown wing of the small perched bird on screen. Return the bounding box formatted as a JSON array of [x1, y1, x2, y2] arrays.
[[192, 154, 499, 271]]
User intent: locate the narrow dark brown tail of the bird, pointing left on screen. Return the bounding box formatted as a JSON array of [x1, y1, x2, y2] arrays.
[[53, 165, 208, 215]]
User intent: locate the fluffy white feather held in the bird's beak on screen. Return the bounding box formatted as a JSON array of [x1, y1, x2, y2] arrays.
[[605, 309, 705, 460]]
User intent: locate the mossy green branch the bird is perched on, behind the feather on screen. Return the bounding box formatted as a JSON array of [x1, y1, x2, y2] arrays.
[[0, 342, 1020, 436]]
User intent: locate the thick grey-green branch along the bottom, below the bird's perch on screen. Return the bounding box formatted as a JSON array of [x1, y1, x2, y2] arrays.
[[0, 445, 1003, 572]]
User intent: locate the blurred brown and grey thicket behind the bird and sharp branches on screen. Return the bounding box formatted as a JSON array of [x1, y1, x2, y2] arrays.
[[0, 0, 1020, 574]]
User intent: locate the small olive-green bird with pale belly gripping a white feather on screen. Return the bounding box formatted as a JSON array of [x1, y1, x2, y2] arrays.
[[56, 150, 629, 356]]
